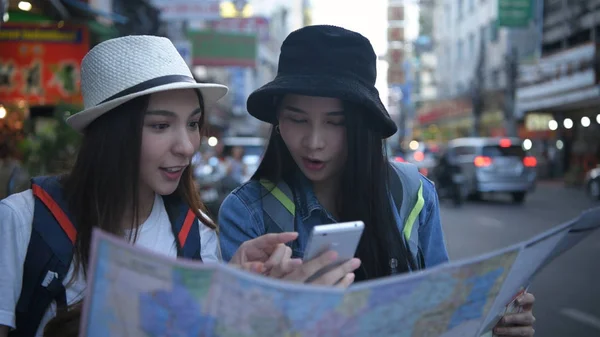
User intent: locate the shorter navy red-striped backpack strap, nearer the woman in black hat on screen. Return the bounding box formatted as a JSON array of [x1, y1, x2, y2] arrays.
[[163, 196, 202, 261]]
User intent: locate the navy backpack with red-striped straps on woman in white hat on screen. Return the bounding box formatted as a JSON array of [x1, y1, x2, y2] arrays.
[[9, 177, 202, 337]]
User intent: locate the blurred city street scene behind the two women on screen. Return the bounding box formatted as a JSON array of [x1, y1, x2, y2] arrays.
[[0, 0, 600, 337]]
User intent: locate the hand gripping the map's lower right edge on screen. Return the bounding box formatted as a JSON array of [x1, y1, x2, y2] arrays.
[[494, 292, 535, 337]]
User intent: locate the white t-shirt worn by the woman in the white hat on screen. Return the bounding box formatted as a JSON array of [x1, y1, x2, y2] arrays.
[[0, 190, 221, 336]]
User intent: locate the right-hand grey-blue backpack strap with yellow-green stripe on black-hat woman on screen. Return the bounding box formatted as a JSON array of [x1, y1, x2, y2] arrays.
[[389, 162, 425, 264]]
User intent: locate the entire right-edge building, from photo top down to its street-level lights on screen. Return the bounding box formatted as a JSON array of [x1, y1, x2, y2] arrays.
[[516, 0, 600, 183]]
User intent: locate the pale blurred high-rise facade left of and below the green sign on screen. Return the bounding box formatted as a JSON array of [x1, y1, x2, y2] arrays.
[[416, 0, 540, 142]]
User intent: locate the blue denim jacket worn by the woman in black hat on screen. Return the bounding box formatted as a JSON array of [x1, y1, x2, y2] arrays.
[[219, 174, 448, 268]]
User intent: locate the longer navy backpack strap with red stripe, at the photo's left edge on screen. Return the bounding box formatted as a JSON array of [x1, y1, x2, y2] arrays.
[[9, 177, 77, 336]]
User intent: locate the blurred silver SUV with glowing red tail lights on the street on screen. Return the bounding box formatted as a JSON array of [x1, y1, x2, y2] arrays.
[[447, 137, 537, 203]]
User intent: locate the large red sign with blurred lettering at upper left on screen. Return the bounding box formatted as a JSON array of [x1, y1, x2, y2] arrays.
[[0, 23, 89, 105]]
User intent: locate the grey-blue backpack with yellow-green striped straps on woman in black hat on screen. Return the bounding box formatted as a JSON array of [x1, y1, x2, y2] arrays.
[[260, 162, 425, 273]]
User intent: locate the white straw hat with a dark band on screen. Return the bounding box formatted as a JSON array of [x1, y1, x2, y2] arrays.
[[67, 35, 227, 131]]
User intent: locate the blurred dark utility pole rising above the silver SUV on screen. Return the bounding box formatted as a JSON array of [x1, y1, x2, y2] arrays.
[[504, 47, 519, 137]]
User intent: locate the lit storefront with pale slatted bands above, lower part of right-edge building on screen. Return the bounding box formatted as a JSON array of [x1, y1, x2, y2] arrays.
[[516, 43, 600, 184]]
